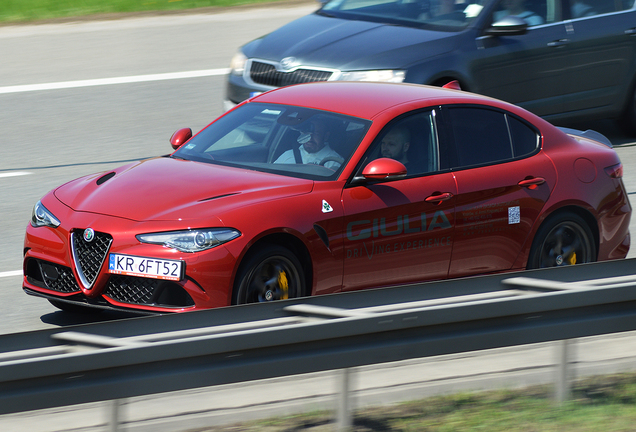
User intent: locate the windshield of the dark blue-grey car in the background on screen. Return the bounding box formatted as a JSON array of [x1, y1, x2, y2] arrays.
[[319, 0, 490, 31]]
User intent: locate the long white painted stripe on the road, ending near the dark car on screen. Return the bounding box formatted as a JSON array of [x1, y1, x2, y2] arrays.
[[0, 68, 230, 94]]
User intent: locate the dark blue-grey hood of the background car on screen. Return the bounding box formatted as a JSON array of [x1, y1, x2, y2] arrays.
[[243, 14, 459, 70]]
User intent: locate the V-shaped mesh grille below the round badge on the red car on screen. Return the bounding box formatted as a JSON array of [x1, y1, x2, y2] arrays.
[[71, 230, 113, 288]]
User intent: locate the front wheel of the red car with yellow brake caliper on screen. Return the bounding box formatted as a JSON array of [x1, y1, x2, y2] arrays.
[[232, 245, 305, 304]]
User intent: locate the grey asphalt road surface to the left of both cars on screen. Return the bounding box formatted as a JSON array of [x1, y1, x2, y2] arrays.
[[0, 1, 316, 334]]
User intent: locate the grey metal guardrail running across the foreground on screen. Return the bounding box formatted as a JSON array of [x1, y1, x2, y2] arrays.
[[0, 260, 636, 422]]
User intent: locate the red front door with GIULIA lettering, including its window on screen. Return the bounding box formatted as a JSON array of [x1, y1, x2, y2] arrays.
[[342, 110, 456, 291]]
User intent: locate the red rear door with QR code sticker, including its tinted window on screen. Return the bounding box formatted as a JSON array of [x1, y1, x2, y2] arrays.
[[443, 106, 556, 277]]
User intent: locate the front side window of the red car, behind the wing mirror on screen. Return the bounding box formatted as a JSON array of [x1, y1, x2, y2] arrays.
[[368, 111, 439, 176]]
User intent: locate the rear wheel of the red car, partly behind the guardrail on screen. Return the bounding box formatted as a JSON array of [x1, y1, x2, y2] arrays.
[[527, 212, 597, 269]]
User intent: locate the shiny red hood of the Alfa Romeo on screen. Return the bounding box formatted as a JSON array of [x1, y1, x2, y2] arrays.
[[54, 157, 313, 221]]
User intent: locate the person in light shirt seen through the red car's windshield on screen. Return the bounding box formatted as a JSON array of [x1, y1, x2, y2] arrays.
[[274, 118, 342, 170]]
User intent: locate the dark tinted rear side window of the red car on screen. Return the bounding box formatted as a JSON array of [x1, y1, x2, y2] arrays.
[[447, 107, 539, 168]]
